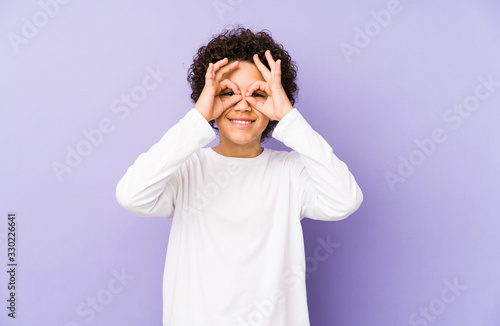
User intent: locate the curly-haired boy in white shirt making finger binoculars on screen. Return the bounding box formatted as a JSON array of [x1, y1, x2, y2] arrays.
[[116, 28, 363, 326]]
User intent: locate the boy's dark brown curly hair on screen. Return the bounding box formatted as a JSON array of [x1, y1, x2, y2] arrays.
[[187, 25, 298, 142]]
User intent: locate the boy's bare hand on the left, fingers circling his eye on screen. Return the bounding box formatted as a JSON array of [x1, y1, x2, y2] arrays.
[[194, 58, 242, 121]]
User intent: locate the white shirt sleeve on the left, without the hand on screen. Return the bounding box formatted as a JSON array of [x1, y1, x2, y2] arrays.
[[116, 108, 216, 217]]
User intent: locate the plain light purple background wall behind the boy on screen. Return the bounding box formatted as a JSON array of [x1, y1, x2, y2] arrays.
[[0, 0, 500, 326]]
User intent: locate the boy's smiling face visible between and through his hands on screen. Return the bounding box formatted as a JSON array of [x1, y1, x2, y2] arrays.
[[215, 61, 269, 146]]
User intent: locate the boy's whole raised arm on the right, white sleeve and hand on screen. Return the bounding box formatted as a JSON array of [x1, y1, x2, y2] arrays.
[[246, 50, 363, 220]]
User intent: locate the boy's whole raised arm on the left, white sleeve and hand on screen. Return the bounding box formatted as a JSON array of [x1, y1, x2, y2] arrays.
[[116, 58, 241, 217]]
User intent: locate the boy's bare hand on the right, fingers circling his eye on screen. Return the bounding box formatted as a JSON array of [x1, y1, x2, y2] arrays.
[[245, 50, 293, 121]]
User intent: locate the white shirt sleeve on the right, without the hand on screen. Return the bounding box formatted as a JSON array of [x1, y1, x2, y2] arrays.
[[272, 108, 363, 221]]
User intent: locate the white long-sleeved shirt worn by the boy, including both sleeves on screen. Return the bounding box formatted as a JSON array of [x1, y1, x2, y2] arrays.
[[116, 108, 363, 326]]
